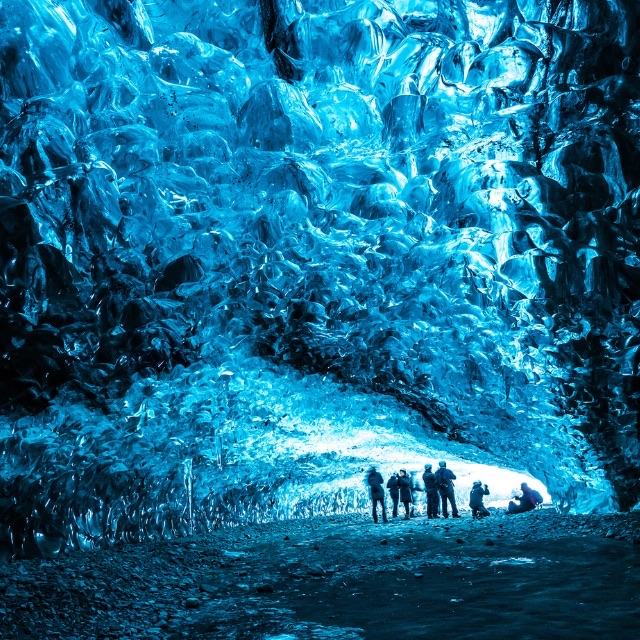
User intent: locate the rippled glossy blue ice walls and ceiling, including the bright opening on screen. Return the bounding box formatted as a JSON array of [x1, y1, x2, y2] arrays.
[[0, 0, 640, 555]]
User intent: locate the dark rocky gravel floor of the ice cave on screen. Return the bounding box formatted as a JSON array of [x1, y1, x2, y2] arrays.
[[0, 509, 640, 640]]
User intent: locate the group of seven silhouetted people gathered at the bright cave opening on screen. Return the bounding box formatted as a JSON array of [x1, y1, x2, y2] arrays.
[[367, 460, 542, 524]]
